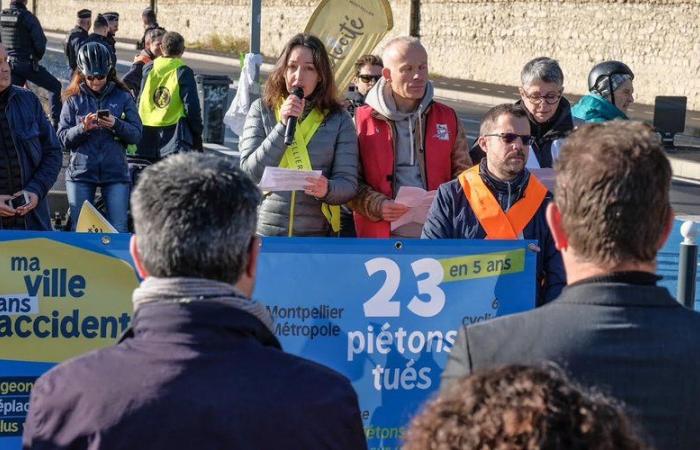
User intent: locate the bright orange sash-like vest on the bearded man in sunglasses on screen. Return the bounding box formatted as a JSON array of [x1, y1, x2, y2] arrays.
[[458, 165, 547, 239]]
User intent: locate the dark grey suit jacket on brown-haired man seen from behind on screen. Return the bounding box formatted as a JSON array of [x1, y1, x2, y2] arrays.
[[442, 282, 700, 450]]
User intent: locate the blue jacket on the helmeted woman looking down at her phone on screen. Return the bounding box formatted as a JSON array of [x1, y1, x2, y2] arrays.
[[58, 82, 142, 184]]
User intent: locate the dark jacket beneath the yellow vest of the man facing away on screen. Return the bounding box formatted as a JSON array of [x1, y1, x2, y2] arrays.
[[137, 61, 204, 160]]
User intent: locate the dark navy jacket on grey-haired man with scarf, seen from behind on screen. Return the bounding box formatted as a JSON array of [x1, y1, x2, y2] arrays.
[[24, 301, 367, 450]]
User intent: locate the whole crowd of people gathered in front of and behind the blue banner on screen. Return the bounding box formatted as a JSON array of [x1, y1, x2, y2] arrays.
[[0, 0, 700, 449]]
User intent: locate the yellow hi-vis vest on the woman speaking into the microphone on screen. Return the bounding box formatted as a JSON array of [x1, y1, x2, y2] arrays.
[[275, 106, 340, 237]]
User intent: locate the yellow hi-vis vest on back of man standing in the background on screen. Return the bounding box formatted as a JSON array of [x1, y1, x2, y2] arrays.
[[139, 56, 185, 127]]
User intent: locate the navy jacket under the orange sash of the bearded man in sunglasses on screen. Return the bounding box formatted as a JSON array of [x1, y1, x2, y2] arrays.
[[421, 162, 566, 306]]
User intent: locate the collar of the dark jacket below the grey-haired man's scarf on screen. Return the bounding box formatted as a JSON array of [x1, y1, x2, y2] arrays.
[[119, 300, 282, 349]]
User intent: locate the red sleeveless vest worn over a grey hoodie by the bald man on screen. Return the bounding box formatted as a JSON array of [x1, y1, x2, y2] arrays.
[[354, 102, 458, 238]]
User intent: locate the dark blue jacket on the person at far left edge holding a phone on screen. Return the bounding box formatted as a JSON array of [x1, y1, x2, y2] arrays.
[[0, 86, 62, 231]]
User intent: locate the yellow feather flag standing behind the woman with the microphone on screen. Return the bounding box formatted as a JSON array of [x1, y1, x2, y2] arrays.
[[304, 0, 394, 94]]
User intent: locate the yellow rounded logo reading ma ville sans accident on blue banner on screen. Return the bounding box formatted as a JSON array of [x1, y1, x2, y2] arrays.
[[0, 238, 138, 362]]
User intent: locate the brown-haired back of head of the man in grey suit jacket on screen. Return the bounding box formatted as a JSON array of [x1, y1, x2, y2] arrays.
[[554, 121, 671, 268]]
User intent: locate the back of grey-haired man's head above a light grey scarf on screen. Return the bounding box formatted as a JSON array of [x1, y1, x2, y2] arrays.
[[131, 153, 260, 283]]
